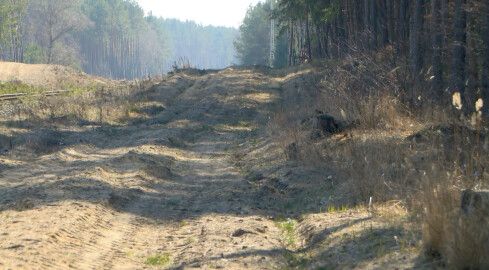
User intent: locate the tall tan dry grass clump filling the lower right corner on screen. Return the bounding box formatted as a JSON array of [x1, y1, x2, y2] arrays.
[[414, 113, 489, 269]]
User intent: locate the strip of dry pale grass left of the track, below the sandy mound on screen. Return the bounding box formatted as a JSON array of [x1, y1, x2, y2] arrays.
[[0, 79, 156, 125]]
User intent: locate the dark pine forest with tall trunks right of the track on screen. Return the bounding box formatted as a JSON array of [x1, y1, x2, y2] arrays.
[[236, 0, 489, 112]]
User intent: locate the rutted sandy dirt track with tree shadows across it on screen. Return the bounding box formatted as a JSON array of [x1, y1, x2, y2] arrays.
[[0, 66, 420, 269]]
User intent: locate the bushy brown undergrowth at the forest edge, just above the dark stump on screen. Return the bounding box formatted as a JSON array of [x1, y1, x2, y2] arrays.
[[316, 53, 412, 129]]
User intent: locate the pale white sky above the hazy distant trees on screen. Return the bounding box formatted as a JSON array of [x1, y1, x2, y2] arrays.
[[138, 0, 259, 28]]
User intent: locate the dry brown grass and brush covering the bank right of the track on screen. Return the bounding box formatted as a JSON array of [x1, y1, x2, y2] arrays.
[[269, 52, 489, 269]]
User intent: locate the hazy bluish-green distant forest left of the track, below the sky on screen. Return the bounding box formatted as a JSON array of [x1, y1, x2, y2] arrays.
[[0, 0, 238, 79]]
